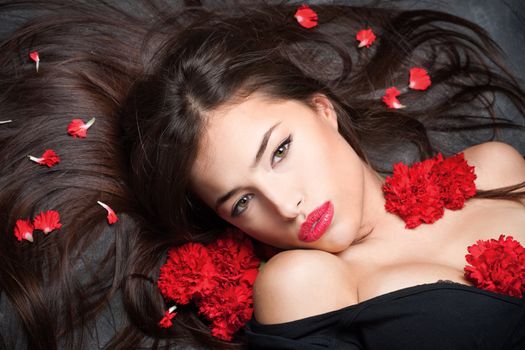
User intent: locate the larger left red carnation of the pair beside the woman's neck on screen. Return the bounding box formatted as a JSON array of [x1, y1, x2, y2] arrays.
[[383, 155, 443, 228]]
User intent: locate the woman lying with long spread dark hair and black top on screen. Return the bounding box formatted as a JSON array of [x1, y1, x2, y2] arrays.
[[0, 0, 525, 349]]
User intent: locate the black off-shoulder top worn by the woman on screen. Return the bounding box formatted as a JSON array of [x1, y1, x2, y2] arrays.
[[246, 281, 525, 350]]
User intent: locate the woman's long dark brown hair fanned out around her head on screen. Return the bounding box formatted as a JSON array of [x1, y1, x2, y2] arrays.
[[0, 1, 525, 349]]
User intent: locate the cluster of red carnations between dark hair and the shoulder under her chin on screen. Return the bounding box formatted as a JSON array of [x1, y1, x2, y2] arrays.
[[157, 229, 260, 341]]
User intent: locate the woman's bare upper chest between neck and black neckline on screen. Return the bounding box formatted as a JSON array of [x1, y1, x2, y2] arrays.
[[343, 200, 525, 301]]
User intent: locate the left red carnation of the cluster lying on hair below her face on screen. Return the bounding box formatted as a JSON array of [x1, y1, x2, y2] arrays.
[[157, 243, 217, 305]]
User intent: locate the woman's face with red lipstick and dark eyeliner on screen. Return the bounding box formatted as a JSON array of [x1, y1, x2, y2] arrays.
[[192, 93, 364, 253]]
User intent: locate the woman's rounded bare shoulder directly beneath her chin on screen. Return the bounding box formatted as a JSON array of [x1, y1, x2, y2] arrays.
[[253, 249, 357, 324]]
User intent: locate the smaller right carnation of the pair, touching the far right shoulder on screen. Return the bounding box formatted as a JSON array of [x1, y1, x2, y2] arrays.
[[439, 153, 476, 210]]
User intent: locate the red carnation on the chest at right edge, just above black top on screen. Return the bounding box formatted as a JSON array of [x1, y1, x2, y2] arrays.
[[464, 235, 525, 298]]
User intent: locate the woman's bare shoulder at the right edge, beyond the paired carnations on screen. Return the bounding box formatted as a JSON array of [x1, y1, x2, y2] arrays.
[[463, 141, 525, 190]]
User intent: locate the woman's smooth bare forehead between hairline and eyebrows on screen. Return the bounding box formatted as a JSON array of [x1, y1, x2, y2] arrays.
[[192, 96, 308, 201]]
